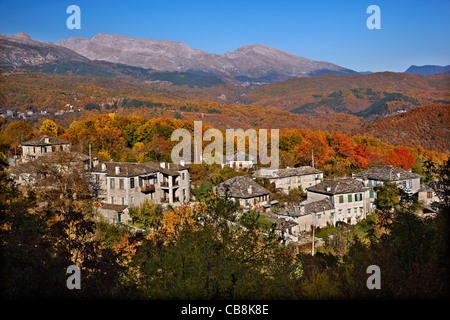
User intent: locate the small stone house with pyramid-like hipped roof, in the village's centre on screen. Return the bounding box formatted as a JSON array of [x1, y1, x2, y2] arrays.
[[214, 176, 270, 209]]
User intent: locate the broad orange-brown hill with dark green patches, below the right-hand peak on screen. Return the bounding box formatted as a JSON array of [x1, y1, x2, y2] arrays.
[[241, 72, 450, 120]]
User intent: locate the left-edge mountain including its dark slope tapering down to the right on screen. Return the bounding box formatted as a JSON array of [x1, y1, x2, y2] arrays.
[[0, 33, 225, 87]]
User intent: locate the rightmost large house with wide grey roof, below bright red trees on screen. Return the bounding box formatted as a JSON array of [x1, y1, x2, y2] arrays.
[[352, 165, 421, 194]]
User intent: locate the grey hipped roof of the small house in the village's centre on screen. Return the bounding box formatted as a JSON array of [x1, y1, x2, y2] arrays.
[[215, 176, 270, 199]]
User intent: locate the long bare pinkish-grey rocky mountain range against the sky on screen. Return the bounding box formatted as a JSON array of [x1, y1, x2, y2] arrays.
[[56, 33, 356, 83]]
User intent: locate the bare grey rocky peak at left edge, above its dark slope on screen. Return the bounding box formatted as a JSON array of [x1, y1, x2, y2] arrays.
[[0, 32, 89, 67]]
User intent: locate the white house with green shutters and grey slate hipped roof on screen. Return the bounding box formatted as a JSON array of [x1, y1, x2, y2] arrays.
[[306, 177, 376, 225]]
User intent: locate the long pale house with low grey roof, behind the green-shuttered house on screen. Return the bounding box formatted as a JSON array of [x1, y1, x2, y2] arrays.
[[253, 166, 323, 193]]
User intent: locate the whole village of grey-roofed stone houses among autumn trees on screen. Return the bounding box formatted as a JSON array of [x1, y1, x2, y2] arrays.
[[10, 135, 438, 243]]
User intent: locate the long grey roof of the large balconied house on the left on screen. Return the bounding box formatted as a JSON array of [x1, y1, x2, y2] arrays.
[[91, 162, 189, 177]]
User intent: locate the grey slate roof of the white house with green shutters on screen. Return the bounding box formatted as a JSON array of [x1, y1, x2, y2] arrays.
[[306, 177, 370, 195]]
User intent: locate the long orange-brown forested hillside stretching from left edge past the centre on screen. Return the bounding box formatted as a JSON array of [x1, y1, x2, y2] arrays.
[[0, 70, 361, 133]]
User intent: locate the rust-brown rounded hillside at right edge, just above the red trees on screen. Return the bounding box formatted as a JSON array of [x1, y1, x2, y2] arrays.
[[353, 104, 450, 153]]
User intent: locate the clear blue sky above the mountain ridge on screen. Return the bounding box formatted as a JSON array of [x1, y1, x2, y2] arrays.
[[0, 0, 450, 72]]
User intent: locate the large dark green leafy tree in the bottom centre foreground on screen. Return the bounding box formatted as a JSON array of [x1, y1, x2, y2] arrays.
[[128, 196, 296, 299]]
